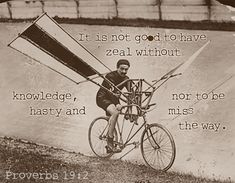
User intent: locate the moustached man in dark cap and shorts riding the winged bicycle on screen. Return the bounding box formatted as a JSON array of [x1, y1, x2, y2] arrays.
[[96, 59, 130, 153]]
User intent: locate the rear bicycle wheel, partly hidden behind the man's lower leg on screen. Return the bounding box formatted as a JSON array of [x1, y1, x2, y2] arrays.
[[88, 117, 118, 158]]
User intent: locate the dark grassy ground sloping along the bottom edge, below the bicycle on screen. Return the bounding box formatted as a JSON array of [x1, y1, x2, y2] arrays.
[[0, 138, 231, 183]]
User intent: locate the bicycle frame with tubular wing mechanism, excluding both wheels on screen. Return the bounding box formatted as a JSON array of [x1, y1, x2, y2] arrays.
[[105, 74, 179, 158]]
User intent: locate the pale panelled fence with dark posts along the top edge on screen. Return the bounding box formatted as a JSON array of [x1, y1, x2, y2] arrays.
[[0, 0, 231, 21]]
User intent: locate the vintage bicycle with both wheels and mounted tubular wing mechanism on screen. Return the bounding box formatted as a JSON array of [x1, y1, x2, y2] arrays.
[[88, 74, 178, 171]]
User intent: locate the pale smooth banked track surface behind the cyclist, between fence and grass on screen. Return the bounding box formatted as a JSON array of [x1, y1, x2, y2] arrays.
[[0, 23, 235, 180]]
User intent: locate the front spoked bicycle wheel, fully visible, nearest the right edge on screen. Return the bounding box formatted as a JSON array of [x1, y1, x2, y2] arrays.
[[140, 123, 176, 171]]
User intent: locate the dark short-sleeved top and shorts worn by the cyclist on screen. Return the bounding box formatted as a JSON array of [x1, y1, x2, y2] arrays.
[[96, 71, 129, 111]]
